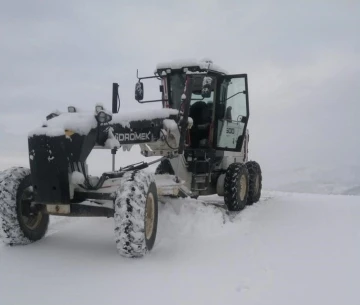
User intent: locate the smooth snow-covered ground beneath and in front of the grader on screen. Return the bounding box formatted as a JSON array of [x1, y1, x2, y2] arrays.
[[0, 192, 360, 305]]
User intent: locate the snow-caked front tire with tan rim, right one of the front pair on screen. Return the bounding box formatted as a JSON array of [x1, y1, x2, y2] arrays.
[[114, 171, 158, 257]]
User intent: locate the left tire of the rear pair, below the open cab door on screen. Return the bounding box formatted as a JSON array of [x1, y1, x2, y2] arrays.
[[224, 163, 249, 211]]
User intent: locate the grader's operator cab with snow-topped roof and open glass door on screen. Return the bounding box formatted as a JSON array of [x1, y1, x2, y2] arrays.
[[135, 61, 249, 151]]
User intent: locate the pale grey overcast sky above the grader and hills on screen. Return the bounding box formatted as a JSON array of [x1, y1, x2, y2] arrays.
[[0, 0, 360, 180]]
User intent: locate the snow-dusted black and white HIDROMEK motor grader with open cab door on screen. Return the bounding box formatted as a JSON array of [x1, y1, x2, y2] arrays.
[[0, 60, 262, 257]]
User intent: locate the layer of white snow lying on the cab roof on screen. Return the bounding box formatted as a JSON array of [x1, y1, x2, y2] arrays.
[[156, 58, 228, 74]]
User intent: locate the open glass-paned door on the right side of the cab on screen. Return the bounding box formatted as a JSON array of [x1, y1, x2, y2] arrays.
[[214, 74, 249, 152]]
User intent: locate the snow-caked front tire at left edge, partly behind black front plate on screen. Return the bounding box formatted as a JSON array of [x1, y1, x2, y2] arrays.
[[0, 167, 49, 246]]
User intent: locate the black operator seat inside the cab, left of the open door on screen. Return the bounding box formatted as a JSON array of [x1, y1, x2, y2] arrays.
[[189, 101, 211, 148]]
